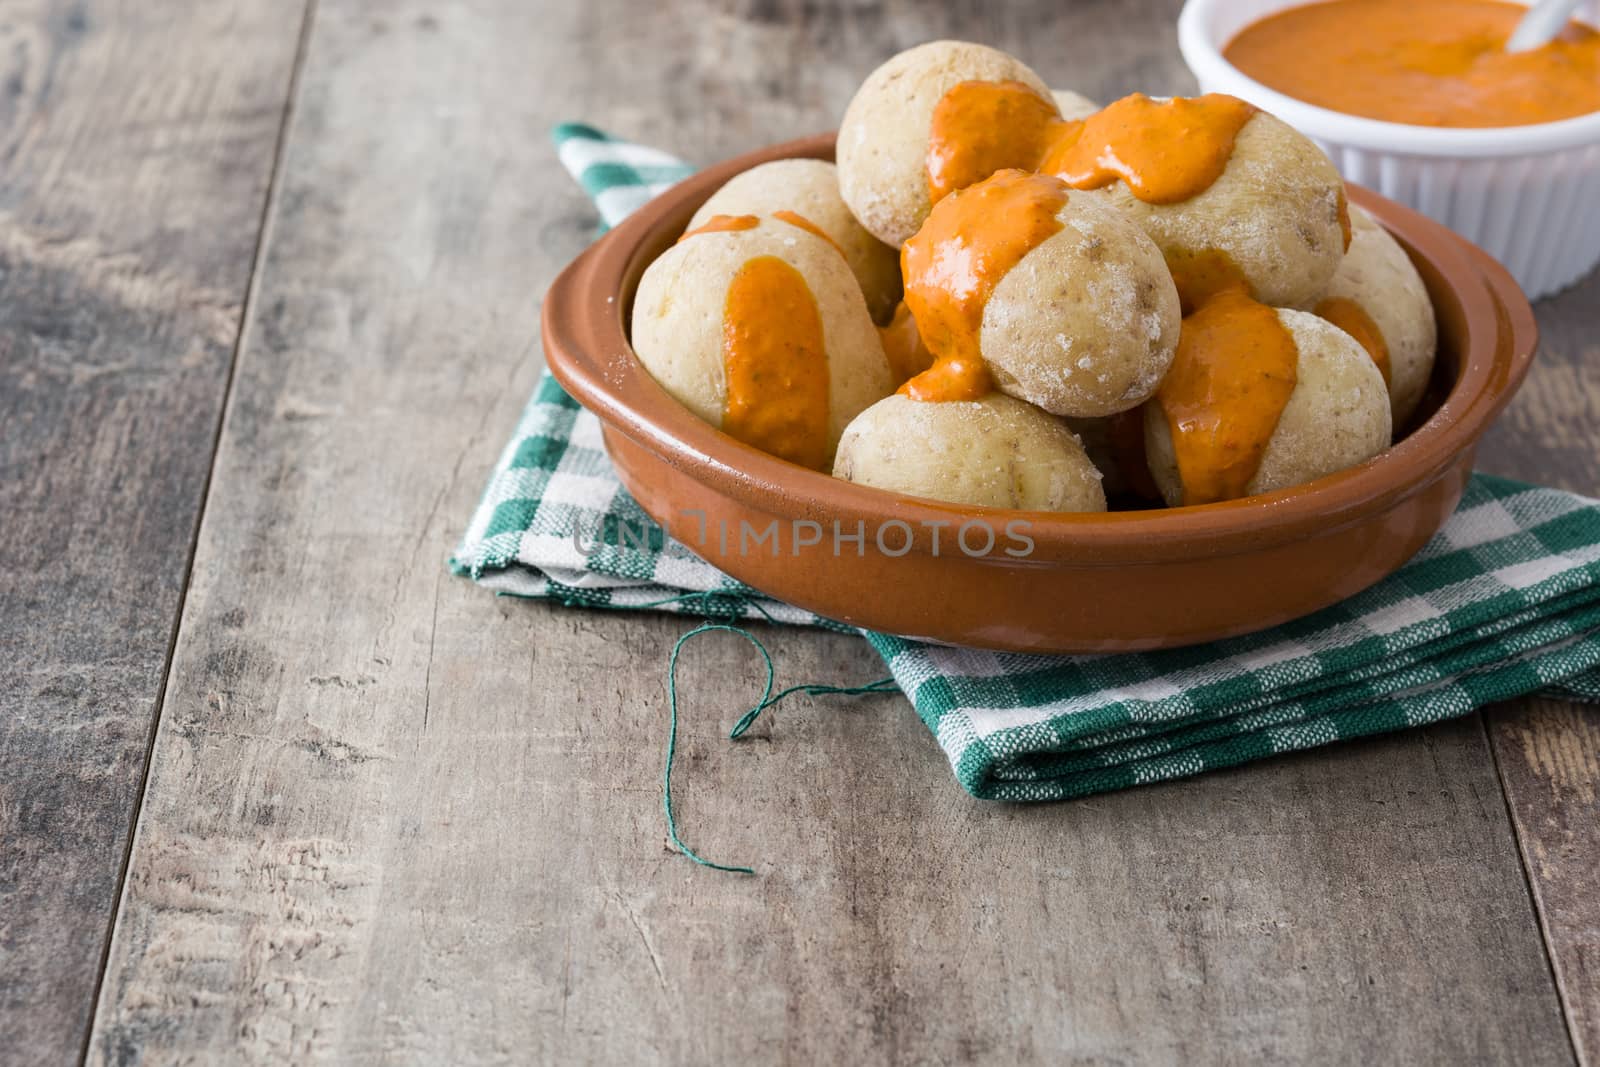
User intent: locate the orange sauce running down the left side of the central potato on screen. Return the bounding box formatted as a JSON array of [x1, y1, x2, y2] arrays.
[[899, 170, 1067, 402]]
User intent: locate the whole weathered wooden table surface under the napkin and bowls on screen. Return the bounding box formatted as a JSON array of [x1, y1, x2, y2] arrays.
[[0, 0, 1600, 1064]]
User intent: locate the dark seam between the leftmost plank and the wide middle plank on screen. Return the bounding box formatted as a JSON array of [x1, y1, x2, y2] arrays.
[[78, 0, 317, 1064]]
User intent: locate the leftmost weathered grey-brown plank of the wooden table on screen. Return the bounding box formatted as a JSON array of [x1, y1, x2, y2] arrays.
[[0, 0, 299, 1064]]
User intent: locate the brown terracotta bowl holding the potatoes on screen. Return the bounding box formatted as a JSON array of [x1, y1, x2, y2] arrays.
[[544, 134, 1536, 653]]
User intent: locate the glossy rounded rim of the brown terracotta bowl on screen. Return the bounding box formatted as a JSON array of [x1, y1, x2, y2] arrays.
[[542, 133, 1538, 565]]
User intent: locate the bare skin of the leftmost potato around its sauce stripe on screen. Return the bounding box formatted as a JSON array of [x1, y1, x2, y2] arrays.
[[632, 218, 894, 470]]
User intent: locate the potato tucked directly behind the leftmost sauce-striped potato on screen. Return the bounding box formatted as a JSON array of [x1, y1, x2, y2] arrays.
[[690, 160, 901, 323]]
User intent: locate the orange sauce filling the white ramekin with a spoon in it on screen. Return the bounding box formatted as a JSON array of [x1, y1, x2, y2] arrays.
[[1222, 0, 1600, 126]]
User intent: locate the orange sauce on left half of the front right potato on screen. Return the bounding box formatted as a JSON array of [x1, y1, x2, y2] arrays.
[[1155, 286, 1299, 504]]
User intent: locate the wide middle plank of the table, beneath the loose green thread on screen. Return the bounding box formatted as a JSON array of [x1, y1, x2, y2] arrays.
[[91, 0, 1571, 1064]]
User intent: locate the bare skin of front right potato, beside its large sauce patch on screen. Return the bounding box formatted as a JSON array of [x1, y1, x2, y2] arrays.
[[1144, 309, 1392, 507]]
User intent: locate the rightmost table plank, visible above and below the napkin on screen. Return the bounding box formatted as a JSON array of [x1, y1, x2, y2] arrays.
[[1478, 274, 1600, 1064]]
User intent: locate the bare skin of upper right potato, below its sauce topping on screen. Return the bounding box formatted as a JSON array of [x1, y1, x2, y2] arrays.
[[1093, 112, 1344, 307]]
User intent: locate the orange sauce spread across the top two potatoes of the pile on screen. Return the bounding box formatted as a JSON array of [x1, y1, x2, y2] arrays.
[[926, 82, 1256, 203]]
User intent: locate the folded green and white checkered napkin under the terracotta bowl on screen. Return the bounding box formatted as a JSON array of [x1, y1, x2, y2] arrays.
[[451, 125, 1600, 800]]
